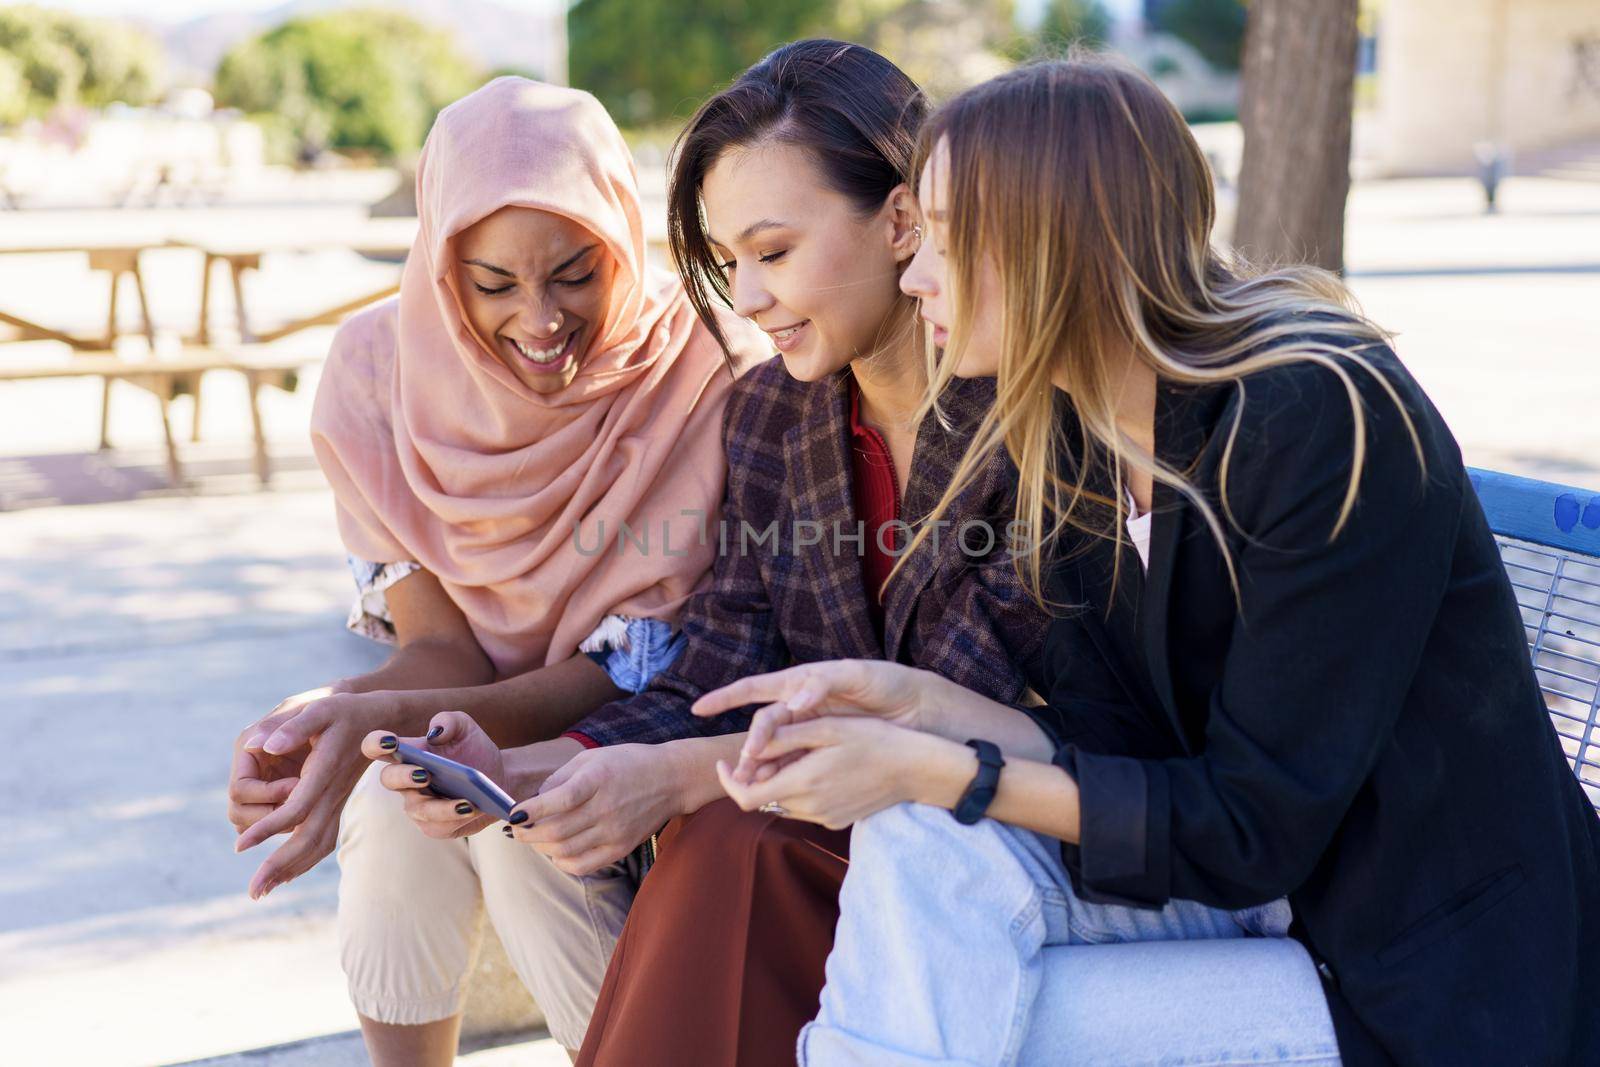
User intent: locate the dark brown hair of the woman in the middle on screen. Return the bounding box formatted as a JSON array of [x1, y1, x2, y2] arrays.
[[667, 38, 928, 350]]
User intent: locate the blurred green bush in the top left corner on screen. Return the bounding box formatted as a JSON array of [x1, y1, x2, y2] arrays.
[[0, 5, 163, 122]]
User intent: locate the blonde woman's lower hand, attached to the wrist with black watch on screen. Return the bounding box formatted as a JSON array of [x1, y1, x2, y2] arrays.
[[717, 717, 976, 830]]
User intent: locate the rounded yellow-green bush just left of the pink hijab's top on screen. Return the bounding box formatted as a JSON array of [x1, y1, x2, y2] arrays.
[[216, 10, 482, 155]]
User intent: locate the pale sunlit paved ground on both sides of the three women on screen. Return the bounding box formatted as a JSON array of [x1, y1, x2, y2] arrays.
[[0, 171, 1600, 1067]]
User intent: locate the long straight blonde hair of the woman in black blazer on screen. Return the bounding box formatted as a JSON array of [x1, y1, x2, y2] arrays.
[[899, 53, 1422, 605]]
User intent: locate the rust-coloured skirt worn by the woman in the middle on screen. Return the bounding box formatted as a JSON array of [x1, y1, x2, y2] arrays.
[[578, 800, 850, 1067]]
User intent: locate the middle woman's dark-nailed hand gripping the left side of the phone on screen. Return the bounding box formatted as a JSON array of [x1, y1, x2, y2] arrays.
[[362, 712, 506, 840]]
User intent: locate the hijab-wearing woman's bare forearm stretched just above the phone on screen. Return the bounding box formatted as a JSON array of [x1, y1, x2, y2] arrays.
[[380, 656, 627, 749]]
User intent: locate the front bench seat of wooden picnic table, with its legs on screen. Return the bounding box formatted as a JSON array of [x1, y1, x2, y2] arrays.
[[0, 347, 317, 486]]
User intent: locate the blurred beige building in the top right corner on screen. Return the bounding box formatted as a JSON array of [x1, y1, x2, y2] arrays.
[[1358, 0, 1600, 174]]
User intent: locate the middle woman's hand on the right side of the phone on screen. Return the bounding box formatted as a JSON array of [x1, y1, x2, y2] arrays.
[[512, 742, 683, 875]]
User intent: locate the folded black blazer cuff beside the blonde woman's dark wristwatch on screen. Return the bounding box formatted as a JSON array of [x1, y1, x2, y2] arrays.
[[1053, 745, 1171, 907]]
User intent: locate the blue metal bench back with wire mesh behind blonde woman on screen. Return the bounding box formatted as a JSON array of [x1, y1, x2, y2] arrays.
[[1469, 469, 1600, 811]]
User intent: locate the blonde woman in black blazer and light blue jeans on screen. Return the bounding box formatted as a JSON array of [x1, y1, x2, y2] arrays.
[[696, 58, 1600, 1065]]
